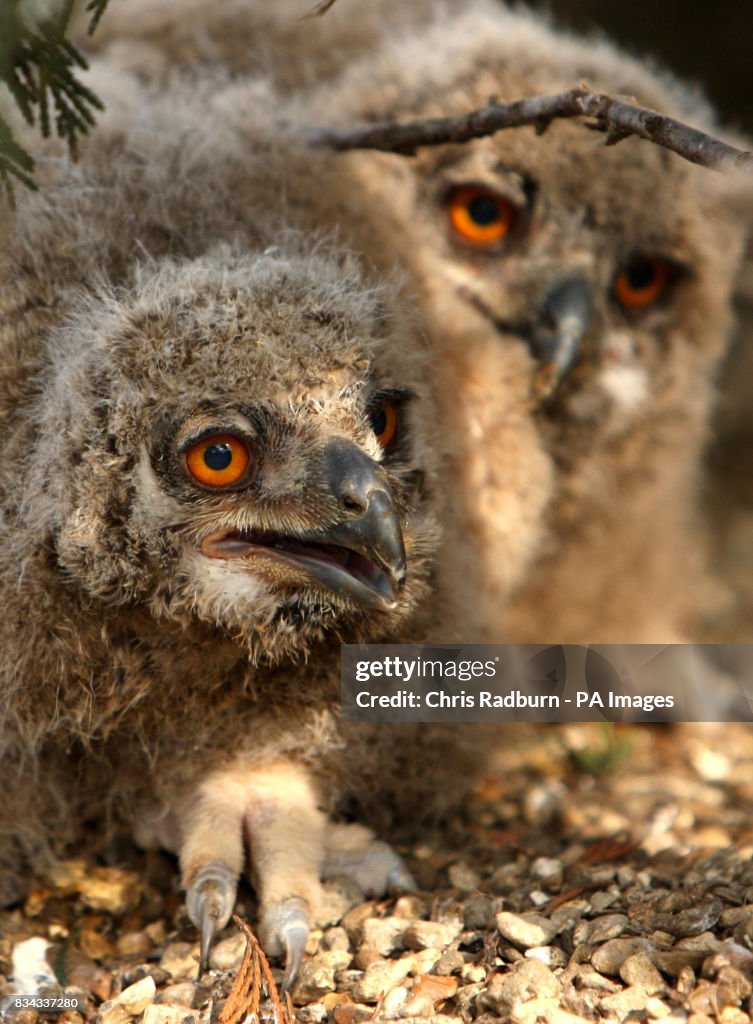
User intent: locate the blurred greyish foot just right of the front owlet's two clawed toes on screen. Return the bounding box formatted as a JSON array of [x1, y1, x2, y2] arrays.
[[322, 824, 417, 896]]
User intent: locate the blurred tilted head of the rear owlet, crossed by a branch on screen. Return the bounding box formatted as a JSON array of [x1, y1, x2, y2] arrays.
[[306, 0, 743, 434]]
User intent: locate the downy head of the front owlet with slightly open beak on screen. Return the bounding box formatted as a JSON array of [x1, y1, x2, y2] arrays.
[[28, 247, 434, 656]]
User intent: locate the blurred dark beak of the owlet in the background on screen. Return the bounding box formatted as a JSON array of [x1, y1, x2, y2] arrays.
[[529, 274, 593, 399]]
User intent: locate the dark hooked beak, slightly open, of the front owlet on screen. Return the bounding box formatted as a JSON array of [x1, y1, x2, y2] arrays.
[[201, 438, 406, 611]]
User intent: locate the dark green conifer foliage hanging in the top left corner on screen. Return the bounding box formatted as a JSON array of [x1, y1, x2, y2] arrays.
[[0, 0, 108, 198]]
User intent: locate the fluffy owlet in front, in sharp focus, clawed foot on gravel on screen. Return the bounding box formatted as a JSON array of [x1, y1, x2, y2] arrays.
[[0, 64, 450, 974]]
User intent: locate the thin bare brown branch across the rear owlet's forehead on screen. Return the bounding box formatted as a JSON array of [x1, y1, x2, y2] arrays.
[[311, 87, 753, 173]]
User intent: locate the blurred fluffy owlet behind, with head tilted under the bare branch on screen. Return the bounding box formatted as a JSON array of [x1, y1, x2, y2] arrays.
[[77, 0, 746, 642]]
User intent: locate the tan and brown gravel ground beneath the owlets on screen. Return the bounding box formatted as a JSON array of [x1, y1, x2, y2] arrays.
[[0, 725, 753, 1024]]
